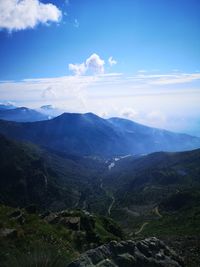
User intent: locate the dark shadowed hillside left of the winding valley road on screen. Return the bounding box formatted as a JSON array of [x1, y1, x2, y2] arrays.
[[0, 135, 107, 213]]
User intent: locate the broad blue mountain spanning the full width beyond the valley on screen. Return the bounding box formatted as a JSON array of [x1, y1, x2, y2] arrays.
[[0, 113, 200, 157]]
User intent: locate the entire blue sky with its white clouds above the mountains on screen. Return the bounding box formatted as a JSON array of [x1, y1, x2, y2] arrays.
[[0, 0, 200, 136]]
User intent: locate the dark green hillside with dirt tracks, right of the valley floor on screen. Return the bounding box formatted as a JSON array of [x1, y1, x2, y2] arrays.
[[103, 149, 200, 243]]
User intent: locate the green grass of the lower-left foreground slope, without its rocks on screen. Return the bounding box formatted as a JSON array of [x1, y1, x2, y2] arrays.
[[0, 205, 123, 266]]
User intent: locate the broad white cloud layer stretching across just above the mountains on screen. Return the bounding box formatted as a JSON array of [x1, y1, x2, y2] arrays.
[[0, 70, 200, 134]]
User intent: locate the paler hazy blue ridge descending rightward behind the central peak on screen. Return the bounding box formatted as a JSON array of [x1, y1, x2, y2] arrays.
[[109, 118, 200, 154]]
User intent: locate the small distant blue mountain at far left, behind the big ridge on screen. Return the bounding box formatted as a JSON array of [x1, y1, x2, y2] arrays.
[[0, 107, 49, 122]]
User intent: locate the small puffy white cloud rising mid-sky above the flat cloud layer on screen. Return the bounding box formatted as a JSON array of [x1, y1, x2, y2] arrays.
[[68, 53, 105, 75]]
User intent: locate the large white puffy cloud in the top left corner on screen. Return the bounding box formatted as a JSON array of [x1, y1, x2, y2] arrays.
[[0, 0, 62, 32]]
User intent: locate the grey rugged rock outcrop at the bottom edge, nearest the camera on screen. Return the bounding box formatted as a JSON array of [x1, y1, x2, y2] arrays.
[[68, 237, 184, 267]]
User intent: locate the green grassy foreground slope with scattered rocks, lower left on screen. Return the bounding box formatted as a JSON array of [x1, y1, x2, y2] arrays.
[[0, 205, 123, 267]]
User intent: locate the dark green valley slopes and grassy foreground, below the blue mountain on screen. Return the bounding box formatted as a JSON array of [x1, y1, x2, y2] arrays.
[[0, 136, 200, 267]]
